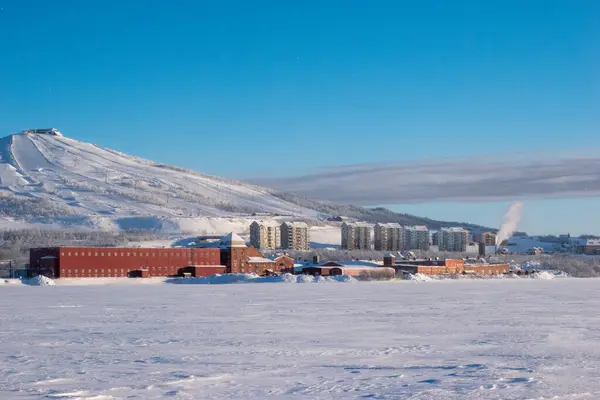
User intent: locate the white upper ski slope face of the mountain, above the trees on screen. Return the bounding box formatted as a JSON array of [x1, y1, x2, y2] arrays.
[[0, 133, 317, 228]]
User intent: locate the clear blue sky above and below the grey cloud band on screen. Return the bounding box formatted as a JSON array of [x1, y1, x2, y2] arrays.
[[0, 0, 600, 233]]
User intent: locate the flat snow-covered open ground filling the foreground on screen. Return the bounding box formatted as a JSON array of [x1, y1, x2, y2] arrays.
[[0, 278, 600, 400]]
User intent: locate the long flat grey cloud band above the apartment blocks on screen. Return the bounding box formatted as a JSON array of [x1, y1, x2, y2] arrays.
[[250, 154, 600, 205]]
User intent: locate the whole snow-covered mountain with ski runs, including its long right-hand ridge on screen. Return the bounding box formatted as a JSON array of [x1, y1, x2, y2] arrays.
[[0, 130, 492, 236]]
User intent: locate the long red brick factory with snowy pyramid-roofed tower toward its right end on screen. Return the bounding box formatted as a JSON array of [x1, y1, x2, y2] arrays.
[[29, 233, 293, 278]]
